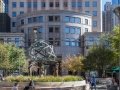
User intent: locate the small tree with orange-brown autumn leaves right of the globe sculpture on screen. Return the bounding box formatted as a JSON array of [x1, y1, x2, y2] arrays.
[[62, 55, 84, 74]]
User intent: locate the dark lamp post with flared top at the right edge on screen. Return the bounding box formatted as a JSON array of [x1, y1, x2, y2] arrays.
[[113, 6, 120, 90]]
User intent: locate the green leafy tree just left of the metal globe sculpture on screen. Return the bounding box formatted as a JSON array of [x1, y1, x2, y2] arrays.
[[4, 44, 26, 71]]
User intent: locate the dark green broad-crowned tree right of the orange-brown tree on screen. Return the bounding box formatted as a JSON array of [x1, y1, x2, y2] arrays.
[[83, 35, 117, 77]]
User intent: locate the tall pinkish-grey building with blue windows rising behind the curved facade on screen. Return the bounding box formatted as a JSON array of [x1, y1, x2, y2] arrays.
[[8, 0, 102, 32]]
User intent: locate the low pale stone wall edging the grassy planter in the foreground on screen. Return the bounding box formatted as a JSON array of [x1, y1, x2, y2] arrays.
[[0, 80, 86, 90]]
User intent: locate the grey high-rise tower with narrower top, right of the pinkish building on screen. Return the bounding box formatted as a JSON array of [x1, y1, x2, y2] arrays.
[[102, 2, 114, 32]]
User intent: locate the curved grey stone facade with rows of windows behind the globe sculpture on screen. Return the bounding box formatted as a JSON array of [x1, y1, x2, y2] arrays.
[[17, 10, 92, 60]]
